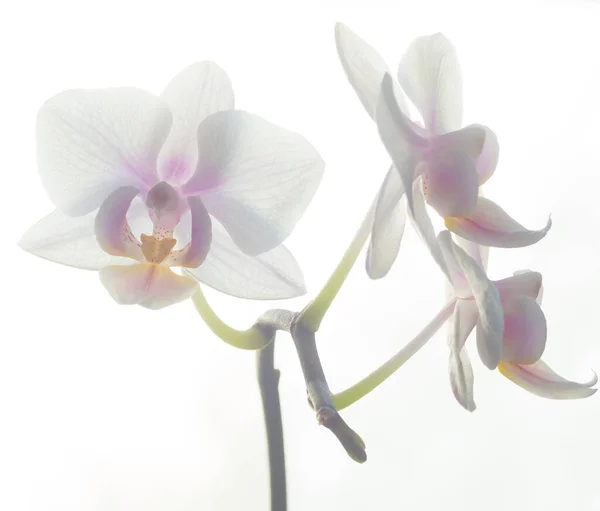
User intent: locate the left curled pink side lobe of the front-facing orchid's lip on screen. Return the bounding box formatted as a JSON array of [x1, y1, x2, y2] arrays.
[[95, 186, 144, 261]]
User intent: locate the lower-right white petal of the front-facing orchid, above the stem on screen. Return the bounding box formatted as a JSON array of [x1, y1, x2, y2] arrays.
[[186, 222, 306, 300]]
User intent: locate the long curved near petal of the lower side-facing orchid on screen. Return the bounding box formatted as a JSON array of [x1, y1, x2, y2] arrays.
[[438, 231, 504, 369]]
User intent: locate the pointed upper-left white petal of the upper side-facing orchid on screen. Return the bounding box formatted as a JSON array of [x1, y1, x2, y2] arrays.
[[335, 23, 407, 118]]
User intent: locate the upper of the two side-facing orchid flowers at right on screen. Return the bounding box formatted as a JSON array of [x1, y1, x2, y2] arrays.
[[336, 23, 551, 278]]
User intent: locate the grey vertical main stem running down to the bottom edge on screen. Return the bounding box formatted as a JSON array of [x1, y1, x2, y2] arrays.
[[256, 342, 287, 511]]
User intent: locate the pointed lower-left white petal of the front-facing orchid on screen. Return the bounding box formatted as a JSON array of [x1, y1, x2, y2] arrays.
[[19, 211, 133, 270]]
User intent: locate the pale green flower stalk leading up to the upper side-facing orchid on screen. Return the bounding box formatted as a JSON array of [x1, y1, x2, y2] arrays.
[[298, 199, 377, 332]]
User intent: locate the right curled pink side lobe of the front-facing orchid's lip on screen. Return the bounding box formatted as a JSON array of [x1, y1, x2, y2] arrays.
[[165, 197, 212, 268]]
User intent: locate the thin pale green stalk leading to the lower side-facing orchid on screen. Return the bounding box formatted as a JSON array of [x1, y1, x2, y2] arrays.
[[332, 299, 456, 410]]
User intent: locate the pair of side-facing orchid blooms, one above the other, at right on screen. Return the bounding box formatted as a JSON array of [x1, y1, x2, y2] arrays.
[[336, 24, 597, 410]]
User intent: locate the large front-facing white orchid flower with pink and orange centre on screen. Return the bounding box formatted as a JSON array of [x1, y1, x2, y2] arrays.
[[20, 62, 324, 309]]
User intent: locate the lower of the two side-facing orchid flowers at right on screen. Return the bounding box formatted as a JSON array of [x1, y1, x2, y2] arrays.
[[438, 231, 598, 411]]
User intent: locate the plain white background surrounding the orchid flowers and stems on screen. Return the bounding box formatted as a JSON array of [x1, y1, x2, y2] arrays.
[[0, 0, 600, 511]]
